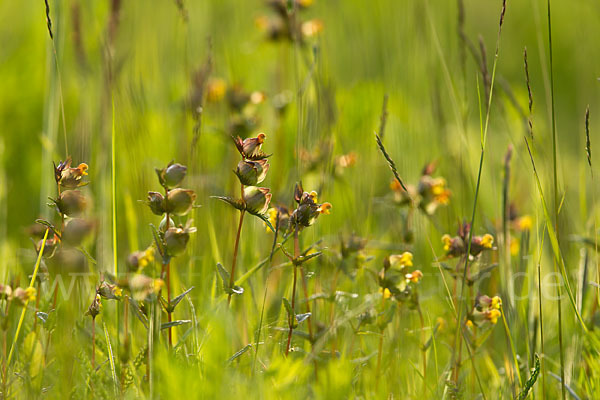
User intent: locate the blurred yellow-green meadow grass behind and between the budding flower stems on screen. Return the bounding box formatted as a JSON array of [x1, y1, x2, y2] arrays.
[[0, 0, 600, 398]]
